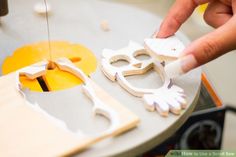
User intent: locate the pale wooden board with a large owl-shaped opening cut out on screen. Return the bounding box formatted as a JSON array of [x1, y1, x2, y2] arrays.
[[0, 61, 139, 157]]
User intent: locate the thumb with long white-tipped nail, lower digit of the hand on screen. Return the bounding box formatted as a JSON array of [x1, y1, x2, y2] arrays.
[[165, 16, 236, 77]]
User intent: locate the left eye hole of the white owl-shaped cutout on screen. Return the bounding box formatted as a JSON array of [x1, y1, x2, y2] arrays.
[[110, 56, 130, 68]]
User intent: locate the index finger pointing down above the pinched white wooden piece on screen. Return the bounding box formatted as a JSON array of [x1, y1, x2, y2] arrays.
[[155, 0, 211, 38]]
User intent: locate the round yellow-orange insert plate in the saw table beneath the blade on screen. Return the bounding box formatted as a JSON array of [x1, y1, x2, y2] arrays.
[[2, 41, 97, 92]]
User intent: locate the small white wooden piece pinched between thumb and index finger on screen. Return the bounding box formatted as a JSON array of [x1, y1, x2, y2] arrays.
[[144, 36, 185, 61]]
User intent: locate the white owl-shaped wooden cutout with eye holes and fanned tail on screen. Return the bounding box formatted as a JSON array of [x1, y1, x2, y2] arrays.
[[102, 41, 187, 116]]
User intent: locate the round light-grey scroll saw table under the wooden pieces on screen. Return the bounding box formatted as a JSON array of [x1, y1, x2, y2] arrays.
[[0, 0, 201, 157]]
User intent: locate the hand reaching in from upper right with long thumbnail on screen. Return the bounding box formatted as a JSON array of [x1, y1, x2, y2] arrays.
[[155, 0, 236, 76]]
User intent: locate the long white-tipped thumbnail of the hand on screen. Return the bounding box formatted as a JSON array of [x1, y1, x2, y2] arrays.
[[165, 55, 198, 78]]
